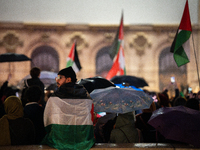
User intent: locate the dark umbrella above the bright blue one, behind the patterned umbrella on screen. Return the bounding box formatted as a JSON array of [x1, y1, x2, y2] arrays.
[[110, 75, 148, 88]]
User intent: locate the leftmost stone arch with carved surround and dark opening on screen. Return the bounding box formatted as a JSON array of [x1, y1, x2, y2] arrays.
[[24, 33, 68, 72]]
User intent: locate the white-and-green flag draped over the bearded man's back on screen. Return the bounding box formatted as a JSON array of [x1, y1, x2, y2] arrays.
[[42, 97, 95, 150]]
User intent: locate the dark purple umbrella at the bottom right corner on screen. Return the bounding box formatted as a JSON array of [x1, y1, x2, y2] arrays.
[[148, 106, 200, 147]]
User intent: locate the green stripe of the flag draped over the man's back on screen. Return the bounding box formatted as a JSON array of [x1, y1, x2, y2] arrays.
[[42, 124, 95, 150]]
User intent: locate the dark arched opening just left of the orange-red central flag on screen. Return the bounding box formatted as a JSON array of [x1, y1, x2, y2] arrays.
[[96, 46, 113, 78]]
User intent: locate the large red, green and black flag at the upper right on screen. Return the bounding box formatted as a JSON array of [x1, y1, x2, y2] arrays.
[[170, 0, 192, 67]]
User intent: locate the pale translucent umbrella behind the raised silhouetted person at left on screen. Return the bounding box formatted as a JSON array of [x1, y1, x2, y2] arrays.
[[18, 71, 57, 89]]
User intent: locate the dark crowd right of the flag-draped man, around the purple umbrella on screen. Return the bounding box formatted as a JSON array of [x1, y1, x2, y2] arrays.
[[95, 83, 200, 143]]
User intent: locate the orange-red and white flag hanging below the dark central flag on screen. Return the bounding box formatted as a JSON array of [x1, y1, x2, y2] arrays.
[[106, 45, 126, 80]]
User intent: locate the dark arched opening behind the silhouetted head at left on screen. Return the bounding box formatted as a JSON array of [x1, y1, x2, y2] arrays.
[[31, 46, 59, 72]]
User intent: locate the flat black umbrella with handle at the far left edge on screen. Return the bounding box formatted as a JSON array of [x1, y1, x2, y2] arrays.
[[0, 53, 31, 72]]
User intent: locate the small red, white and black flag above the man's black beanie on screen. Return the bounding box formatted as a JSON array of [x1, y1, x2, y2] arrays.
[[66, 42, 82, 73]]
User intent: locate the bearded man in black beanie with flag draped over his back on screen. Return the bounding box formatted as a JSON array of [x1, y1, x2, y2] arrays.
[[42, 67, 95, 150]]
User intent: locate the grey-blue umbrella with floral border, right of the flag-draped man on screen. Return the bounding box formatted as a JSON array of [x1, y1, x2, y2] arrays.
[[90, 87, 153, 113]]
